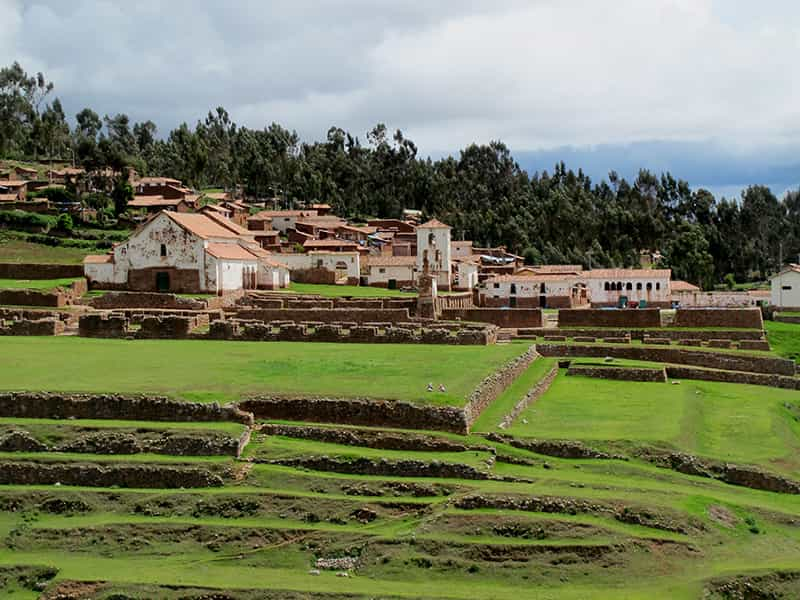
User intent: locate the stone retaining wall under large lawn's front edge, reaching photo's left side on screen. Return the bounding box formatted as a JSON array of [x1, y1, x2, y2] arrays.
[[0, 392, 253, 425]]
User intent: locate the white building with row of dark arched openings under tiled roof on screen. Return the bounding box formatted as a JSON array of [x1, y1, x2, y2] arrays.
[[582, 269, 672, 308]]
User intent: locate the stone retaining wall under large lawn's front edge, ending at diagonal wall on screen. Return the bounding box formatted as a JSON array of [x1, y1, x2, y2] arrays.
[[239, 396, 467, 433]]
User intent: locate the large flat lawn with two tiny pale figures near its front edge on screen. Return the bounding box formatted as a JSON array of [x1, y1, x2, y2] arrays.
[[0, 337, 528, 406]]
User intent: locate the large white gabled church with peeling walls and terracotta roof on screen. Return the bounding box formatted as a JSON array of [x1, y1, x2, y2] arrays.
[[83, 211, 288, 294]]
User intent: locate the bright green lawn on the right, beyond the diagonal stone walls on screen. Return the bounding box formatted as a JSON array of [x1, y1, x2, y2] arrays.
[[509, 373, 800, 476]]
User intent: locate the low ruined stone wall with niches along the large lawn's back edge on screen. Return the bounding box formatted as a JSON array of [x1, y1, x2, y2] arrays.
[[208, 320, 497, 346]]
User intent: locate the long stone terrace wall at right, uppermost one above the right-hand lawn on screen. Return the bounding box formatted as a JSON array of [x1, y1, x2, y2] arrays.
[[536, 344, 795, 376]]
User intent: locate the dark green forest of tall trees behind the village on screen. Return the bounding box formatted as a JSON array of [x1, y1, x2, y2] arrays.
[[0, 63, 800, 288]]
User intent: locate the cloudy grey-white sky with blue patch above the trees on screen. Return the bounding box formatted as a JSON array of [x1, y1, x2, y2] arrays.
[[0, 0, 800, 191]]
